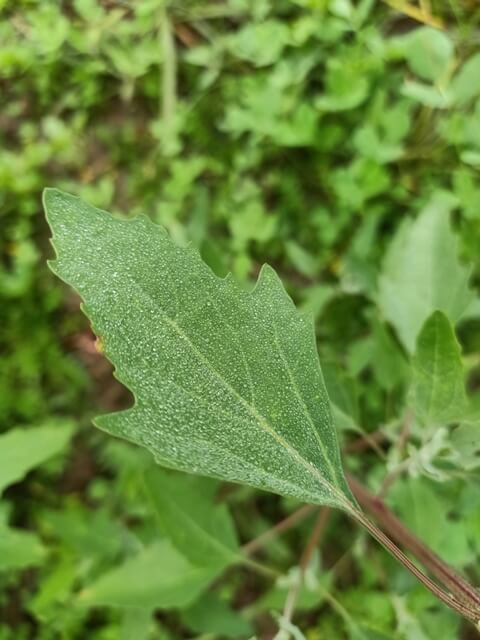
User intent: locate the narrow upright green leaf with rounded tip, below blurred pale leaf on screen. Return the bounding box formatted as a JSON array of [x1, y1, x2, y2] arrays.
[[412, 311, 467, 424]]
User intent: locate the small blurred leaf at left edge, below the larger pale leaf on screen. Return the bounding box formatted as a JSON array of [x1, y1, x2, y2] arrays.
[[0, 525, 46, 572]]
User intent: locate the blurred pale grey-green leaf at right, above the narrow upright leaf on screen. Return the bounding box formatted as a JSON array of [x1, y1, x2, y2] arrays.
[[378, 194, 473, 353]]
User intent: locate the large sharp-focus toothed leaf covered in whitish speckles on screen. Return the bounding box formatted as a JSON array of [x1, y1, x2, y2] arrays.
[[45, 189, 356, 512]]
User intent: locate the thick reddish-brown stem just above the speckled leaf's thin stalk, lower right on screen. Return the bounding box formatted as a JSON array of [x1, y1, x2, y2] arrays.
[[348, 476, 480, 617]]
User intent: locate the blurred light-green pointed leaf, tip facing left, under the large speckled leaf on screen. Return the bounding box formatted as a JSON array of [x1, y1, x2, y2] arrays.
[[78, 540, 218, 609]]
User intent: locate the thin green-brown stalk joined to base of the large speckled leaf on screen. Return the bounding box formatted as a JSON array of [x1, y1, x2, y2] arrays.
[[350, 509, 480, 625]]
